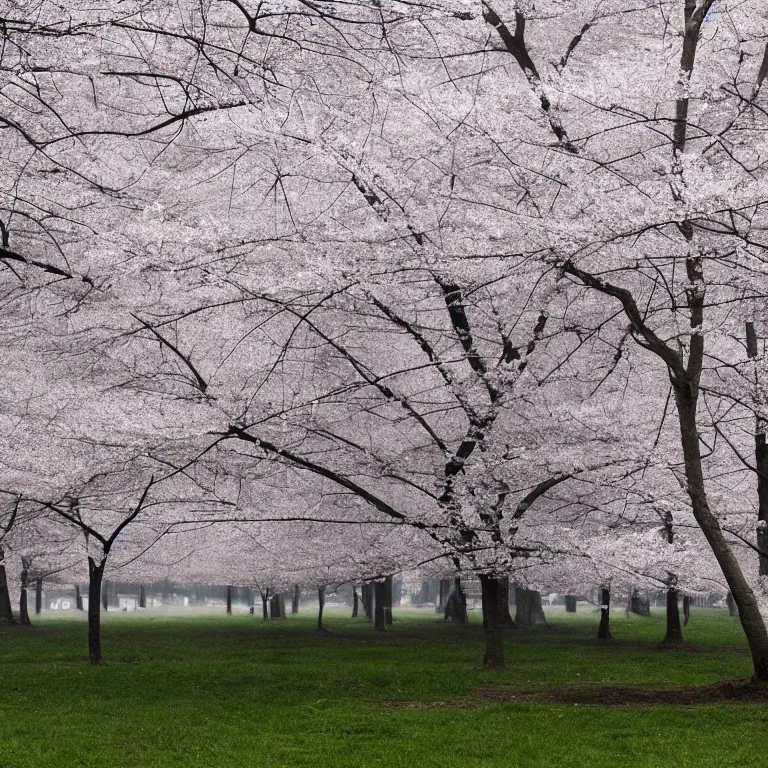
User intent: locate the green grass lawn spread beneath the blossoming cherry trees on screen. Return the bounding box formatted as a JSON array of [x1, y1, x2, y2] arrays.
[[0, 606, 768, 768]]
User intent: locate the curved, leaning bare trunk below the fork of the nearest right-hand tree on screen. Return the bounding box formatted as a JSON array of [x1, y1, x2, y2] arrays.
[[675, 392, 768, 682]]
